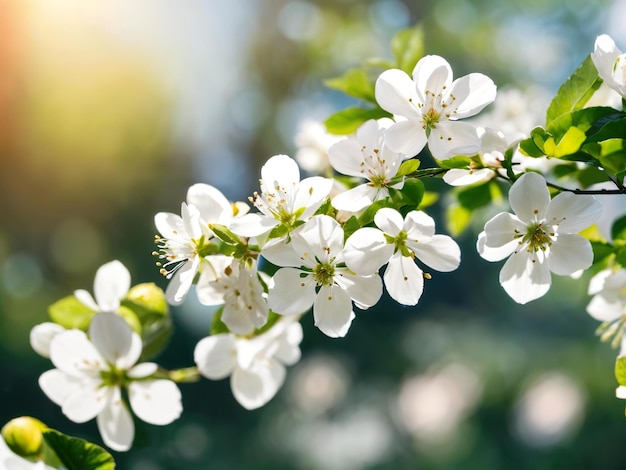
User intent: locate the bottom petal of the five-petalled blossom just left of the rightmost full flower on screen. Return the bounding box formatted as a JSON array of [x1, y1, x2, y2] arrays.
[[383, 253, 424, 305]]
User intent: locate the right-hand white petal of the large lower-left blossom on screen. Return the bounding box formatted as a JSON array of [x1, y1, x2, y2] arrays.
[[128, 380, 183, 426]]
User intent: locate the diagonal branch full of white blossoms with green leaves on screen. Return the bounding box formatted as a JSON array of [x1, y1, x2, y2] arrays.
[[24, 29, 626, 462]]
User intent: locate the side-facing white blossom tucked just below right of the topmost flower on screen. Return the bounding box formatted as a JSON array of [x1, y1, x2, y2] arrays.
[[443, 127, 509, 186]]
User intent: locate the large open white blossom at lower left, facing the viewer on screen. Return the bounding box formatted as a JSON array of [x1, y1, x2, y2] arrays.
[[39, 312, 182, 451]]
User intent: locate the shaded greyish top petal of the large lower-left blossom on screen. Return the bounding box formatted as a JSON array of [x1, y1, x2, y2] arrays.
[[89, 312, 133, 364]]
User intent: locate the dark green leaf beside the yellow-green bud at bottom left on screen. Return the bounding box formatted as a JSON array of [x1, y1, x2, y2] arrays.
[[43, 429, 115, 470]]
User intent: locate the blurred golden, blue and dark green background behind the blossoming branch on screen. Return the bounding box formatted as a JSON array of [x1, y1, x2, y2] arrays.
[[0, 0, 626, 470]]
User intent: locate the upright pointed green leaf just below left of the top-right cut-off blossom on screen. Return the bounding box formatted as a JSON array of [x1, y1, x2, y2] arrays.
[[546, 55, 602, 128]]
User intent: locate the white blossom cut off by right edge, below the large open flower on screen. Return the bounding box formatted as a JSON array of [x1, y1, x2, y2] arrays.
[[587, 268, 626, 346]]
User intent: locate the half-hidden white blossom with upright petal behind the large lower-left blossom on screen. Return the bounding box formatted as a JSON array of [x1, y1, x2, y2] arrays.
[[74, 260, 130, 312]]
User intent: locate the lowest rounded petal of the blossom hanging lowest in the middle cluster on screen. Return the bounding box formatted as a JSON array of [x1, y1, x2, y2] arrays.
[[230, 360, 286, 410]]
